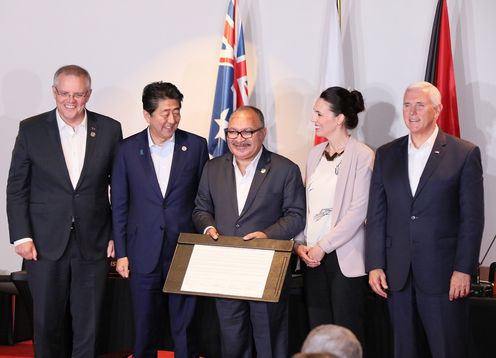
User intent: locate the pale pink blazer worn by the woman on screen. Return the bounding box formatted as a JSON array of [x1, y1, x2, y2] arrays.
[[295, 137, 374, 277]]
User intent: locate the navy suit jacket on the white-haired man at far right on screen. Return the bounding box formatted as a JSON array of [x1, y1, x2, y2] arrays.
[[365, 130, 484, 294]]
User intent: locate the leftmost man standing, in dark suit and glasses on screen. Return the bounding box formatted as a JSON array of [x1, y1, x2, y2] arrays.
[[7, 65, 122, 358]]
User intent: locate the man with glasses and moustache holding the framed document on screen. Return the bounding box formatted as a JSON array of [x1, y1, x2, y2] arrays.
[[193, 106, 305, 358]]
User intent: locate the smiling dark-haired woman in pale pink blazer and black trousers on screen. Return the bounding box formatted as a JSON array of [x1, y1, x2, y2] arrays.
[[294, 87, 374, 352]]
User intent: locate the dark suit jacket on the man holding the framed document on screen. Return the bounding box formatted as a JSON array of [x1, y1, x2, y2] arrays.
[[193, 148, 305, 240]]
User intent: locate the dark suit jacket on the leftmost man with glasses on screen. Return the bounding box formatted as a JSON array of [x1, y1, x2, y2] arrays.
[[7, 110, 122, 260]]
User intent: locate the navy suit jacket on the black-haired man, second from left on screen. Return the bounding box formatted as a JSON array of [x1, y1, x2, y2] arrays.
[[111, 129, 208, 274]]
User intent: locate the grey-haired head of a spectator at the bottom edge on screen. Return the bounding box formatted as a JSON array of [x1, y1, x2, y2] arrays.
[[301, 324, 362, 358]]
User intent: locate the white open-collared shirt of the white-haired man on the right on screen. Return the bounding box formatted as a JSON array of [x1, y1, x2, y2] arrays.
[[408, 125, 439, 196]]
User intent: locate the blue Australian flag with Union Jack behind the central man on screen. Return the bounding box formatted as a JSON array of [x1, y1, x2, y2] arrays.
[[208, 0, 248, 157]]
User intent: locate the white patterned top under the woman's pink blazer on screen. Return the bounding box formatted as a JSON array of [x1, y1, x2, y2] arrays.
[[307, 156, 343, 246]]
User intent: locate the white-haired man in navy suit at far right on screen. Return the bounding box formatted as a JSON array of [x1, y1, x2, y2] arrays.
[[365, 82, 484, 358]]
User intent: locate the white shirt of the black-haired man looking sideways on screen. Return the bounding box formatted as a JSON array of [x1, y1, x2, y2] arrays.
[[148, 128, 175, 197]]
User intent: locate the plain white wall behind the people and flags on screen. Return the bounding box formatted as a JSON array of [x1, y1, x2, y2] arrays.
[[0, 0, 496, 273]]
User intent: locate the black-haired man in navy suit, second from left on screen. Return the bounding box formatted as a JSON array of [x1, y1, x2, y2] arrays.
[[112, 82, 208, 358]]
